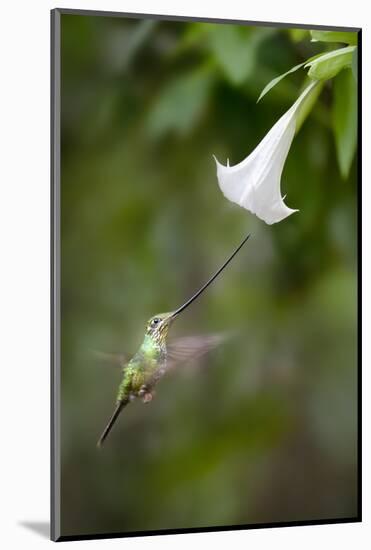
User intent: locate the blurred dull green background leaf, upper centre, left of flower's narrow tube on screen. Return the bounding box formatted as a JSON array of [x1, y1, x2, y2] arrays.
[[147, 68, 213, 137]]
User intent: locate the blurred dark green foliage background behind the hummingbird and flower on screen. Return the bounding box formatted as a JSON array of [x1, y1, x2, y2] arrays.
[[61, 14, 357, 535]]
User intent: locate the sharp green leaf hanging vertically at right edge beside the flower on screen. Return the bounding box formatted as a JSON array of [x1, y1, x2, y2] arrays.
[[332, 69, 357, 179]]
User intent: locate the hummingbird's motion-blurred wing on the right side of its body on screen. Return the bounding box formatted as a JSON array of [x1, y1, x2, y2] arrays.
[[166, 333, 228, 369]]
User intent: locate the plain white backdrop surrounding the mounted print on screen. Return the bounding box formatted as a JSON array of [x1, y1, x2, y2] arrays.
[[0, 0, 371, 550]]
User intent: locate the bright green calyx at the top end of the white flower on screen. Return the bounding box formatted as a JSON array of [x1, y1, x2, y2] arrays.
[[305, 46, 356, 80]]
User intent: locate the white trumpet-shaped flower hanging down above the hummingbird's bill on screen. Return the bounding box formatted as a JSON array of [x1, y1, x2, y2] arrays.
[[214, 81, 317, 225]]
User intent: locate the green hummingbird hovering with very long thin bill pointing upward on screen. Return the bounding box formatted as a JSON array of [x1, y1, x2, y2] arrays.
[[97, 234, 250, 447]]
